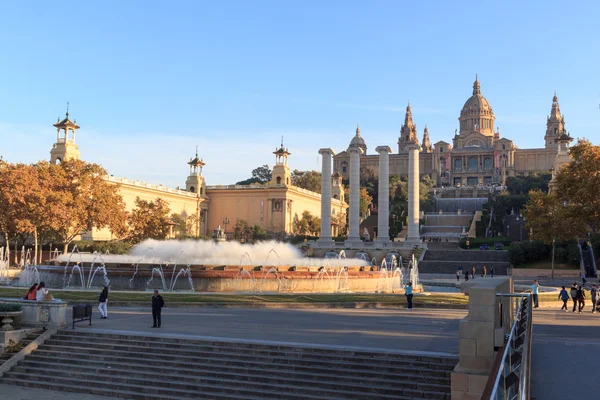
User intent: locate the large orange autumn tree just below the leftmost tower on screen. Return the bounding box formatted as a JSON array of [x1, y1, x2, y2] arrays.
[[41, 160, 127, 252]]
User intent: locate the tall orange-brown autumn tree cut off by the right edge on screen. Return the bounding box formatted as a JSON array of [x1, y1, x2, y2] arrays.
[[553, 139, 600, 233]]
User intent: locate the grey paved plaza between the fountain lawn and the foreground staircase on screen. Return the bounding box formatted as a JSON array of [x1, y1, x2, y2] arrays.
[[68, 307, 466, 353]]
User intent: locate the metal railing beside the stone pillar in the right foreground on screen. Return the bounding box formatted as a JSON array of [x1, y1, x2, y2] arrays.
[[481, 293, 533, 400]]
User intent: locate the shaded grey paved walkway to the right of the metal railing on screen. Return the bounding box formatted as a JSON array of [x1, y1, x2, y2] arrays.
[[531, 305, 600, 400]]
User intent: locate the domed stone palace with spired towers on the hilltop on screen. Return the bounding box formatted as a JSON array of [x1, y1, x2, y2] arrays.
[[334, 76, 565, 186]]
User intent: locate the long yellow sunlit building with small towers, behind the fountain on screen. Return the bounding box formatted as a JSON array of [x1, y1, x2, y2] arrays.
[[50, 114, 348, 240]]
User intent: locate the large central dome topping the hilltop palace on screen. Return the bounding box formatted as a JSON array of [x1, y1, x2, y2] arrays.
[[458, 76, 496, 134]]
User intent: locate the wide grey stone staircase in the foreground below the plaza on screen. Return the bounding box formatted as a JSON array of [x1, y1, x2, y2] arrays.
[[0, 330, 457, 400]]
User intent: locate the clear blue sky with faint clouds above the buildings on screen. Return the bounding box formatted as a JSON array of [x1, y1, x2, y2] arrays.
[[0, 0, 600, 187]]
